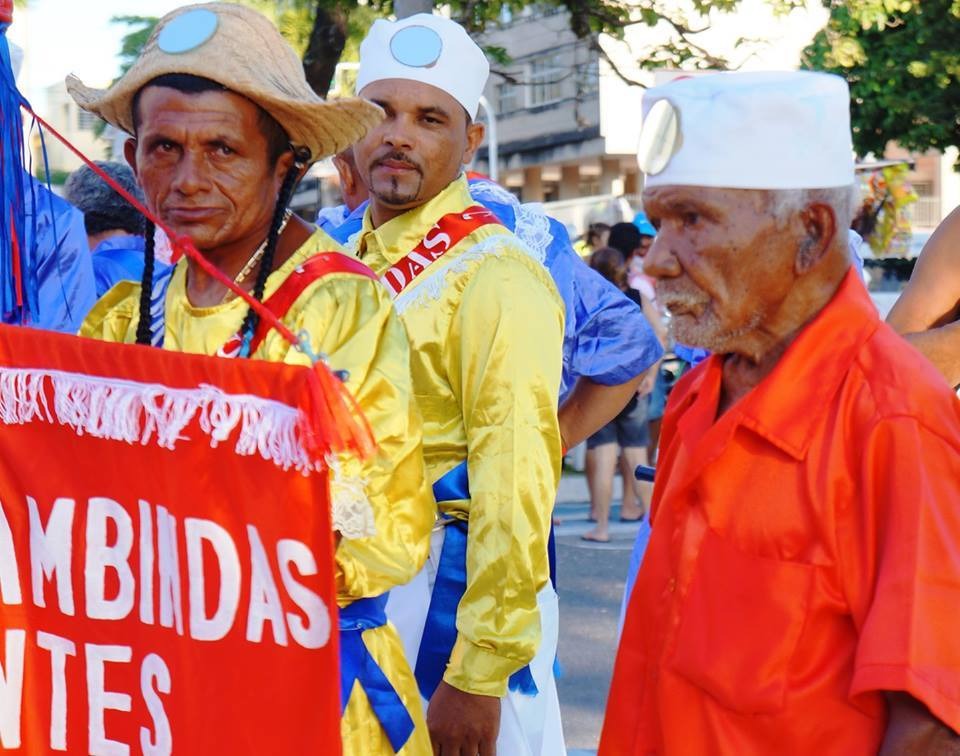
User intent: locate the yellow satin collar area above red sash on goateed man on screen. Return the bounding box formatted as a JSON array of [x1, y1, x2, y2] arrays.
[[357, 174, 473, 264]]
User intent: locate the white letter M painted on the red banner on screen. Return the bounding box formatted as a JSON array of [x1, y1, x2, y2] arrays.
[[27, 496, 76, 617]]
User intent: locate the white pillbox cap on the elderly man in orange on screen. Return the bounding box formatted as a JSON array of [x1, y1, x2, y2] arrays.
[[638, 71, 854, 189]]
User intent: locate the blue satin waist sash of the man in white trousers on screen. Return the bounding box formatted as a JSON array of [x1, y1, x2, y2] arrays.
[[413, 461, 553, 701]]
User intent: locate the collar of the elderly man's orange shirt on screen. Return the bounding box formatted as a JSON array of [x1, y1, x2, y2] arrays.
[[684, 268, 880, 459]]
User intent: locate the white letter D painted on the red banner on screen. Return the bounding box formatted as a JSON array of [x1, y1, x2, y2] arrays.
[[183, 517, 240, 641]]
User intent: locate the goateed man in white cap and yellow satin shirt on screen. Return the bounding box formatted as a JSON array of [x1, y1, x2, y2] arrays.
[[354, 14, 564, 756]]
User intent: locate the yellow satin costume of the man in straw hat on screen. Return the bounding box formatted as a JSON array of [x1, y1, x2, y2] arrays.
[[80, 231, 435, 756]]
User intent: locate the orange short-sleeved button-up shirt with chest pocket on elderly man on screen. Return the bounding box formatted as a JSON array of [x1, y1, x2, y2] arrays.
[[600, 272, 960, 756]]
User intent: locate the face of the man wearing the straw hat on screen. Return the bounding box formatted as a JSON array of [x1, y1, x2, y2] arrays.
[[126, 86, 291, 251]]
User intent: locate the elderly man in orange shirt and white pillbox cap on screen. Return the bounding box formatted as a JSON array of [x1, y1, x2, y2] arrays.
[[600, 72, 960, 756]]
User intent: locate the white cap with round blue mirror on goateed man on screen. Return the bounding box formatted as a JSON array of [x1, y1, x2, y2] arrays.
[[357, 13, 490, 118]]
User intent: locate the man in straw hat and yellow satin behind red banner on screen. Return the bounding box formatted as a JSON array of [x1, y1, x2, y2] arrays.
[[67, 3, 435, 756]]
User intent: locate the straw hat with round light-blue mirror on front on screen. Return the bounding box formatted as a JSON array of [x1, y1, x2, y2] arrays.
[[66, 3, 383, 160]]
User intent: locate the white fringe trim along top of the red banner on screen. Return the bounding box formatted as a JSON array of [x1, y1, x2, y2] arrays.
[[0, 367, 322, 475]]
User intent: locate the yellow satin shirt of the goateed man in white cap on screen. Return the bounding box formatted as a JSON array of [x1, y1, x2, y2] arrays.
[[356, 177, 564, 696]]
